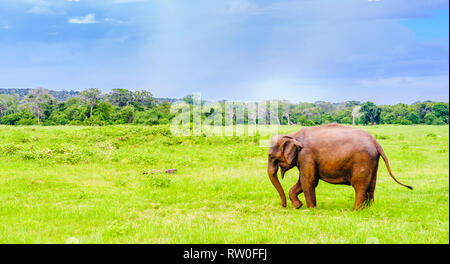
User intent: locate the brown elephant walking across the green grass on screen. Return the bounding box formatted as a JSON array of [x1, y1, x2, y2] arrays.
[[267, 124, 412, 210]]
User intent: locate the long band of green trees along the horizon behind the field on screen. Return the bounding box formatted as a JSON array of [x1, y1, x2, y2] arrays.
[[0, 87, 449, 126]]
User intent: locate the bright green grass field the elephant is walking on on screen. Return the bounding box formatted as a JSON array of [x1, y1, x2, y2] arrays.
[[0, 125, 449, 243]]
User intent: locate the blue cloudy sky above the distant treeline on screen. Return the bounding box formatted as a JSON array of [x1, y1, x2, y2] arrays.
[[0, 0, 449, 104]]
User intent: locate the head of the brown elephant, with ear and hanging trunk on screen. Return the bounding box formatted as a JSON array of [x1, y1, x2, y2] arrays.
[[267, 135, 303, 207]]
